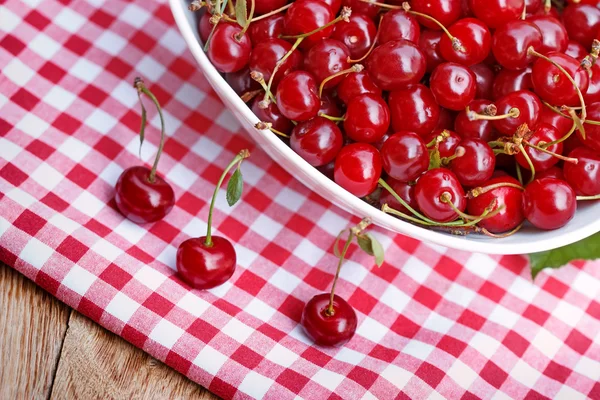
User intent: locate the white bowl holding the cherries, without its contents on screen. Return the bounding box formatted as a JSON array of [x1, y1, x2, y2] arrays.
[[170, 0, 600, 254]]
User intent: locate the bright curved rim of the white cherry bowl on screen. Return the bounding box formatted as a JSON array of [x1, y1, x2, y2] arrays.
[[169, 0, 600, 255]]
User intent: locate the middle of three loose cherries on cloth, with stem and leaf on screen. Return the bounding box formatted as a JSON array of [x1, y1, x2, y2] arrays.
[[176, 150, 250, 290]]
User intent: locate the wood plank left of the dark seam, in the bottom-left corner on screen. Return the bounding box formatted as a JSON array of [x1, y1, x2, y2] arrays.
[[0, 263, 71, 399]]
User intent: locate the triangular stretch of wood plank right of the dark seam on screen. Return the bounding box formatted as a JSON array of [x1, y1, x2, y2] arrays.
[[50, 311, 217, 400]]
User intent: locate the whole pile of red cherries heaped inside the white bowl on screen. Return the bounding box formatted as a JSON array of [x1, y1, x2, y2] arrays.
[[190, 0, 600, 237]]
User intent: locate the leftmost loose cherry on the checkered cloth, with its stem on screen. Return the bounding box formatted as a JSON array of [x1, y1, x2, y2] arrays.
[[115, 78, 175, 224]]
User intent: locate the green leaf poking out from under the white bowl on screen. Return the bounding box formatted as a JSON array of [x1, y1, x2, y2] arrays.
[[529, 232, 600, 279]]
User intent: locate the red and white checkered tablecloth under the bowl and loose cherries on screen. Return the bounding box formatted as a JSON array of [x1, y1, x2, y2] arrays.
[[0, 0, 600, 400]]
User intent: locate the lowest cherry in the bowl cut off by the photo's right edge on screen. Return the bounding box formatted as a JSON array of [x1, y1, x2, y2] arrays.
[[563, 147, 600, 196]]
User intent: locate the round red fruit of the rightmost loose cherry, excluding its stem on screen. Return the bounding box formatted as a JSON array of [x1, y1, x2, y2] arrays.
[[300, 293, 358, 346]]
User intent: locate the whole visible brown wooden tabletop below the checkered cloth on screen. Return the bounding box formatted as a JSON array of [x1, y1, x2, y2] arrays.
[[0, 263, 217, 400]]
